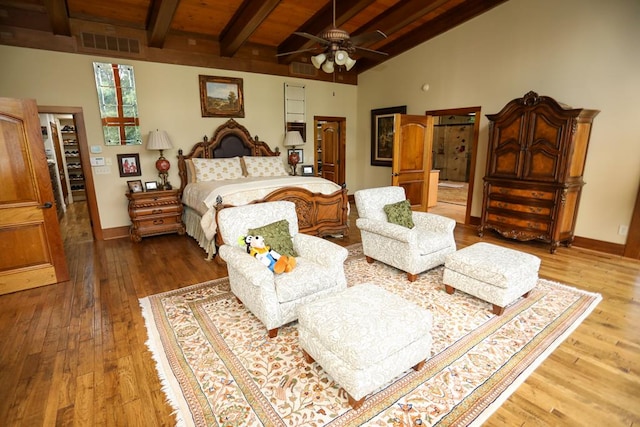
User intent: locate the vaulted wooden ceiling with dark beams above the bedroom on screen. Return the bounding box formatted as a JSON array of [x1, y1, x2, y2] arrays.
[[0, 0, 506, 84]]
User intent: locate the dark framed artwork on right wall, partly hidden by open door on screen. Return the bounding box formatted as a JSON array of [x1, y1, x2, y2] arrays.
[[371, 105, 407, 166]]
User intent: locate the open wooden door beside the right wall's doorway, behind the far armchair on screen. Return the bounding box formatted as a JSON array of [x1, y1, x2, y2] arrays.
[[391, 114, 433, 212]]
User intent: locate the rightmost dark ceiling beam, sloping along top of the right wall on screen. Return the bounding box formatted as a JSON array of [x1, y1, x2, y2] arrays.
[[356, 0, 508, 74]]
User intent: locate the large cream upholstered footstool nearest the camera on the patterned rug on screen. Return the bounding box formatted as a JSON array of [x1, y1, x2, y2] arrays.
[[298, 283, 432, 409]]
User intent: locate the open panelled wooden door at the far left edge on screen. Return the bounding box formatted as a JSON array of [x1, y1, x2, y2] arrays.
[[0, 98, 69, 294]]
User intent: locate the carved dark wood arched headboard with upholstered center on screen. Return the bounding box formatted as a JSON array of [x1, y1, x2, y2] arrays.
[[178, 119, 280, 193]]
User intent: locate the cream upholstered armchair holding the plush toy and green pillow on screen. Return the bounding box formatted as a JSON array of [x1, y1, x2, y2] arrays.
[[218, 201, 348, 338]]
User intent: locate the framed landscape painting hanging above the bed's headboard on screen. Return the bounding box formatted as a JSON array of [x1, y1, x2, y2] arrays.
[[199, 75, 244, 117]]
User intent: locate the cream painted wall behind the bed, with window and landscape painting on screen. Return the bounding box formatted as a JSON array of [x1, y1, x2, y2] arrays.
[[0, 46, 357, 229]]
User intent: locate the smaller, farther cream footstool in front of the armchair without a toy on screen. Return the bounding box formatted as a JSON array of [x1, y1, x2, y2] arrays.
[[442, 242, 540, 315]]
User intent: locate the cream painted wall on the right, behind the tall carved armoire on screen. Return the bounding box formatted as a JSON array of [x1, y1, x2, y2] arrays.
[[358, 0, 640, 244]]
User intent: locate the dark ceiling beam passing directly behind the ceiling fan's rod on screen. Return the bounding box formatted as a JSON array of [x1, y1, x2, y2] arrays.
[[278, 0, 375, 63]]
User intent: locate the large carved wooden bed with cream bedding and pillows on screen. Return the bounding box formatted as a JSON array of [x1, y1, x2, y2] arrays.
[[178, 119, 349, 259]]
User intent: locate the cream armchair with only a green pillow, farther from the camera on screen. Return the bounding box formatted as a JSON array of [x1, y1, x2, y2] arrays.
[[354, 186, 456, 282]]
